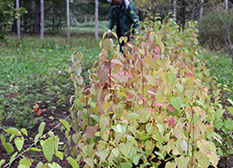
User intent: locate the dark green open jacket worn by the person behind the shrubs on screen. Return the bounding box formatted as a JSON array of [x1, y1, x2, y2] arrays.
[[108, 0, 139, 37]]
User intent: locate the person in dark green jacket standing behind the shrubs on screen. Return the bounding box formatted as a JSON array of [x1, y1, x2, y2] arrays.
[[107, 0, 139, 52]]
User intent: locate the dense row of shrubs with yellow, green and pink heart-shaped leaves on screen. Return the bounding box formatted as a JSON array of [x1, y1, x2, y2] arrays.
[[66, 19, 221, 168]]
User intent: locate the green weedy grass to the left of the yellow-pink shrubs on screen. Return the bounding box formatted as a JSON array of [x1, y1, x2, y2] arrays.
[[0, 33, 100, 129]]
